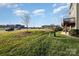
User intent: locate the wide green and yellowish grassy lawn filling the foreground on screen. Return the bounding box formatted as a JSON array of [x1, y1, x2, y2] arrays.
[[0, 30, 79, 56]]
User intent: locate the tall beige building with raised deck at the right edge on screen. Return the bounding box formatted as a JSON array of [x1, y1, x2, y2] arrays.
[[62, 3, 79, 32]]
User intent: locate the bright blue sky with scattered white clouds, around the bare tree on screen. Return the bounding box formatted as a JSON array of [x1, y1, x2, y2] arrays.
[[0, 3, 69, 27]]
